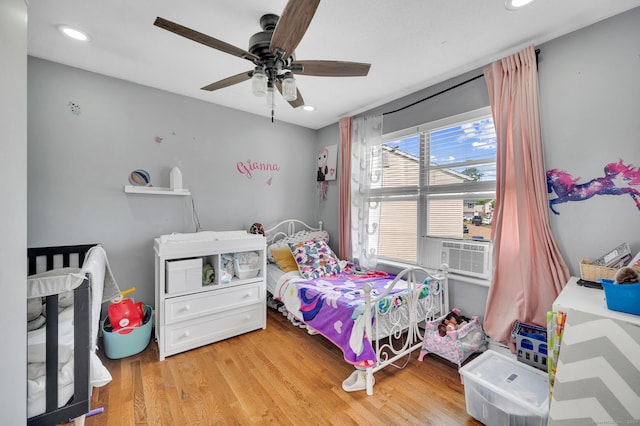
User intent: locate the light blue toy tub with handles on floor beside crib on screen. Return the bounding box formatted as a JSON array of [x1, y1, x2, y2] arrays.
[[102, 305, 153, 359]]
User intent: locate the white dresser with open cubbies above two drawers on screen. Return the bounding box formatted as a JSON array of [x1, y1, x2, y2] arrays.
[[154, 231, 267, 361]]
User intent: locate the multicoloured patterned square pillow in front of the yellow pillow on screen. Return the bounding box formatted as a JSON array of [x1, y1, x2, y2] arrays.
[[289, 240, 340, 279]]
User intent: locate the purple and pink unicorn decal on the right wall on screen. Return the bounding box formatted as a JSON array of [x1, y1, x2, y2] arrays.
[[547, 160, 640, 214]]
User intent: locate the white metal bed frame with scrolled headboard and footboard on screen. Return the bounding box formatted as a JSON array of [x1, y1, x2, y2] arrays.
[[265, 219, 449, 395]]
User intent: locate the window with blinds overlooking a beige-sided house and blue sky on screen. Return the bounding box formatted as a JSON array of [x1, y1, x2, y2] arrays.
[[369, 108, 496, 266]]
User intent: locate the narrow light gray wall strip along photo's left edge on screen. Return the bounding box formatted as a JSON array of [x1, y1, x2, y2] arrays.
[[0, 0, 27, 425]]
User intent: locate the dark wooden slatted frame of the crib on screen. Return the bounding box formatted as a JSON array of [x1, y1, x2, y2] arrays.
[[27, 244, 95, 425]]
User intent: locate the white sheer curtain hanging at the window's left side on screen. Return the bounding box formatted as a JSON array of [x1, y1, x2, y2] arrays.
[[351, 115, 382, 269]]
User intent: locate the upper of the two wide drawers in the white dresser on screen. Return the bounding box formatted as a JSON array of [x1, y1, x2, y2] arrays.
[[164, 282, 266, 324]]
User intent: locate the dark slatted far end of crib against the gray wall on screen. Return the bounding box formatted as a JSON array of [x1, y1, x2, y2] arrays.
[[27, 244, 97, 275]]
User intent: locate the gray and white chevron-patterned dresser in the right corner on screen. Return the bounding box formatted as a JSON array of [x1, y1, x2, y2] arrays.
[[548, 277, 640, 425]]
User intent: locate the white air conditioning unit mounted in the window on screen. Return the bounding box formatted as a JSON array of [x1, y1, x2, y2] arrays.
[[441, 241, 493, 279]]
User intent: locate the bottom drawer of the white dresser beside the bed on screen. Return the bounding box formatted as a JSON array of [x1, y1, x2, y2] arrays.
[[164, 301, 266, 356]]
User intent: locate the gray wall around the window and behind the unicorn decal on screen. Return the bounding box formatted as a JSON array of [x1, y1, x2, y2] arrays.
[[318, 8, 640, 317]]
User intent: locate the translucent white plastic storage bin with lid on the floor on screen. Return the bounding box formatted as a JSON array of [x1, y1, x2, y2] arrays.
[[460, 350, 549, 426]]
